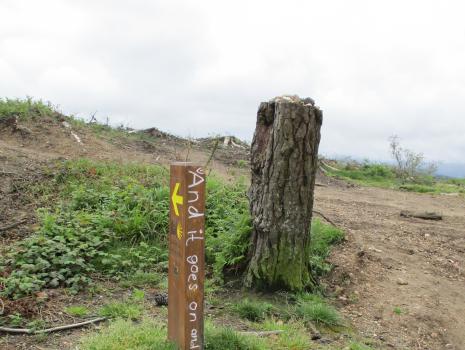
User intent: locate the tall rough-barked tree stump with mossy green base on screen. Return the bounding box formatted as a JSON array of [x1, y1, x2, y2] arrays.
[[245, 96, 323, 290]]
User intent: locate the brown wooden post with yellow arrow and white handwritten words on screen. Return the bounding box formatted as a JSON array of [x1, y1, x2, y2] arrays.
[[168, 162, 205, 350]]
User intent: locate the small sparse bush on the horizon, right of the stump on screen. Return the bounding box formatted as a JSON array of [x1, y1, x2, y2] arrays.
[[389, 135, 437, 180]]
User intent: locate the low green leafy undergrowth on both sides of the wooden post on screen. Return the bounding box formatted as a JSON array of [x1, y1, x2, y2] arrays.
[[0, 160, 254, 298]]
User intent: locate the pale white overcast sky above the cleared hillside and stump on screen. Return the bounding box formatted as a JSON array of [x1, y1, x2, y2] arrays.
[[0, 0, 465, 163]]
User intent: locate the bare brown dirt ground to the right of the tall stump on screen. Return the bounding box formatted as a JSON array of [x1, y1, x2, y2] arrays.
[[316, 185, 465, 350]]
